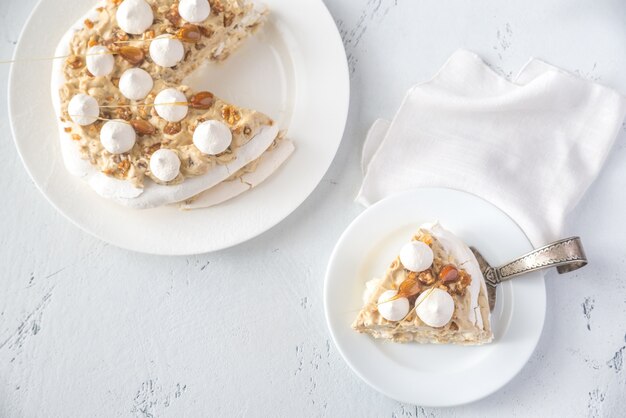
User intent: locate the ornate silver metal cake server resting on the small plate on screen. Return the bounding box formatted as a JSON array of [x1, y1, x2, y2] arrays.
[[471, 237, 587, 311]]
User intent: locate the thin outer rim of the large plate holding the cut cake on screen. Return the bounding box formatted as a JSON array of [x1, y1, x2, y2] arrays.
[[6, 0, 351, 256]]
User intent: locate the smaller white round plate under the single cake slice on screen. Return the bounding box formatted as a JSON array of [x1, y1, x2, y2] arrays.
[[324, 188, 546, 407]]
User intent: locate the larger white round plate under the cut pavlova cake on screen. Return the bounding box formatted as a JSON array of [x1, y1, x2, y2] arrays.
[[9, 0, 349, 255]]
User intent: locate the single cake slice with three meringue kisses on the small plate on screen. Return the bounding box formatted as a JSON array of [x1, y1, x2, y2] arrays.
[[352, 223, 493, 345]]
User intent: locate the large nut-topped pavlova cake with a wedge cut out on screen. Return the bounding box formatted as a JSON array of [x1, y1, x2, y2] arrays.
[[52, 0, 293, 208]]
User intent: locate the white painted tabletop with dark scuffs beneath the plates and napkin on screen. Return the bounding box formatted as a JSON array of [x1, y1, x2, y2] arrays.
[[0, 0, 626, 417]]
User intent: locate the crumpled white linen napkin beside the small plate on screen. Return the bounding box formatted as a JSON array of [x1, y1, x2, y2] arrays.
[[356, 50, 626, 246]]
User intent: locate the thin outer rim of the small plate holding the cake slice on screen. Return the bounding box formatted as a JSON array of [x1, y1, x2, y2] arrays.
[[323, 187, 547, 408]]
